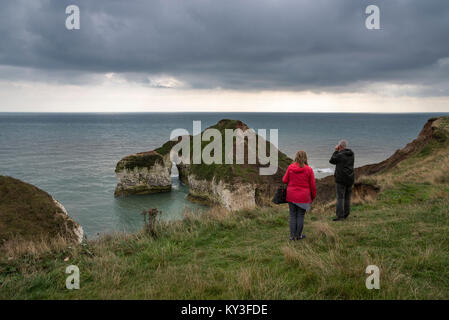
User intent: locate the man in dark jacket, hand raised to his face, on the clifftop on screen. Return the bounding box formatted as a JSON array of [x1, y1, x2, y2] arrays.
[[329, 140, 354, 221]]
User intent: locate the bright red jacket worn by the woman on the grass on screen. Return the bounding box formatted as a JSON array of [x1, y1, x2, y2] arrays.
[[282, 163, 316, 203]]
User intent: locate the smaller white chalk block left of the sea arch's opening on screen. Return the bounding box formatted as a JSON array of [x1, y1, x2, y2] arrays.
[[114, 151, 171, 197]]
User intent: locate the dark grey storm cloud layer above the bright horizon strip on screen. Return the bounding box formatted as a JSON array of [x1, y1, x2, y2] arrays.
[[0, 0, 449, 95]]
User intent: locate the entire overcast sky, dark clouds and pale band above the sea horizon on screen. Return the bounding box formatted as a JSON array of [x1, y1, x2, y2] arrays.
[[0, 0, 449, 112]]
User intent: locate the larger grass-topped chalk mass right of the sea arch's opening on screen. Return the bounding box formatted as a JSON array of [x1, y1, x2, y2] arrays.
[[178, 119, 292, 211]]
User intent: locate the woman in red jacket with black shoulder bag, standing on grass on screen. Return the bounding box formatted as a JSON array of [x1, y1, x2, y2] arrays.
[[282, 150, 316, 240]]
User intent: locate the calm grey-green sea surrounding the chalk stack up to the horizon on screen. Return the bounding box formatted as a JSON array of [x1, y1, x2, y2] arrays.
[[0, 113, 442, 237]]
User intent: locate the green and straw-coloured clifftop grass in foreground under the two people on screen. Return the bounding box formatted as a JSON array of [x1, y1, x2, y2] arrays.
[[0, 184, 449, 299]]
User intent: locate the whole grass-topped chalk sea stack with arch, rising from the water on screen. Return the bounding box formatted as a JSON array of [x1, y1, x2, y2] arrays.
[[115, 119, 292, 210]]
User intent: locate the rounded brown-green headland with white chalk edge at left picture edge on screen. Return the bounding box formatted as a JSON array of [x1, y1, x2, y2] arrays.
[[0, 176, 83, 243]]
